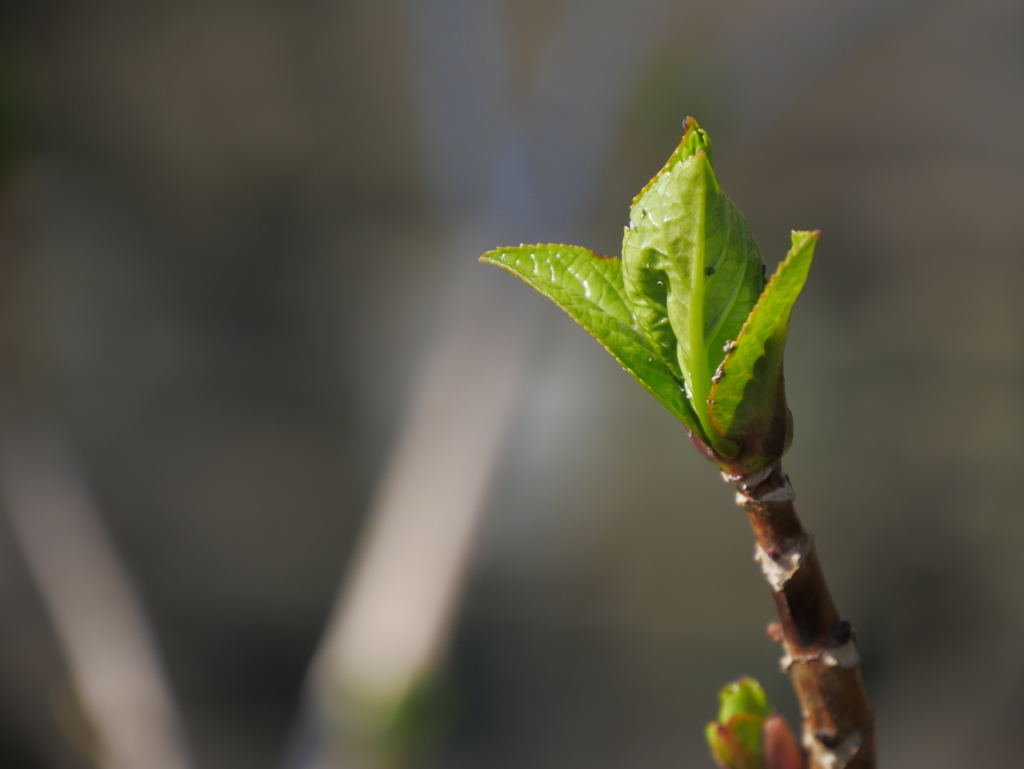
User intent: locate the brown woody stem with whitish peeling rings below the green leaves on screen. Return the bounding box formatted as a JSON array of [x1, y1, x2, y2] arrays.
[[724, 462, 877, 769]]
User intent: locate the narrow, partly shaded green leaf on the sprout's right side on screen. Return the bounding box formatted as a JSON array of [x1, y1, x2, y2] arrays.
[[709, 230, 820, 472]]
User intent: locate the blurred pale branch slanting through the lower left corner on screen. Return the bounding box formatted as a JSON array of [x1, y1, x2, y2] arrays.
[[0, 431, 191, 769]]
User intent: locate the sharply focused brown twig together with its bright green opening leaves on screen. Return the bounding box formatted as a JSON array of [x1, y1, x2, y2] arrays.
[[480, 118, 876, 769]]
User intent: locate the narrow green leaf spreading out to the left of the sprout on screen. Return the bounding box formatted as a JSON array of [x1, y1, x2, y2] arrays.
[[480, 244, 701, 433]]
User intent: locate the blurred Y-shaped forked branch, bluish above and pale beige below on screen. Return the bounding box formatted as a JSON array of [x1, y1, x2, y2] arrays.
[[288, 0, 671, 769]]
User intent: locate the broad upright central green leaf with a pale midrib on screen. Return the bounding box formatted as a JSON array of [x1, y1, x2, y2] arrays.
[[623, 119, 764, 458]]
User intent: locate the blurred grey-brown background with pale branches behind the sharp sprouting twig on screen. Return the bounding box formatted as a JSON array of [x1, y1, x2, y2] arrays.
[[0, 0, 1024, 769]]
